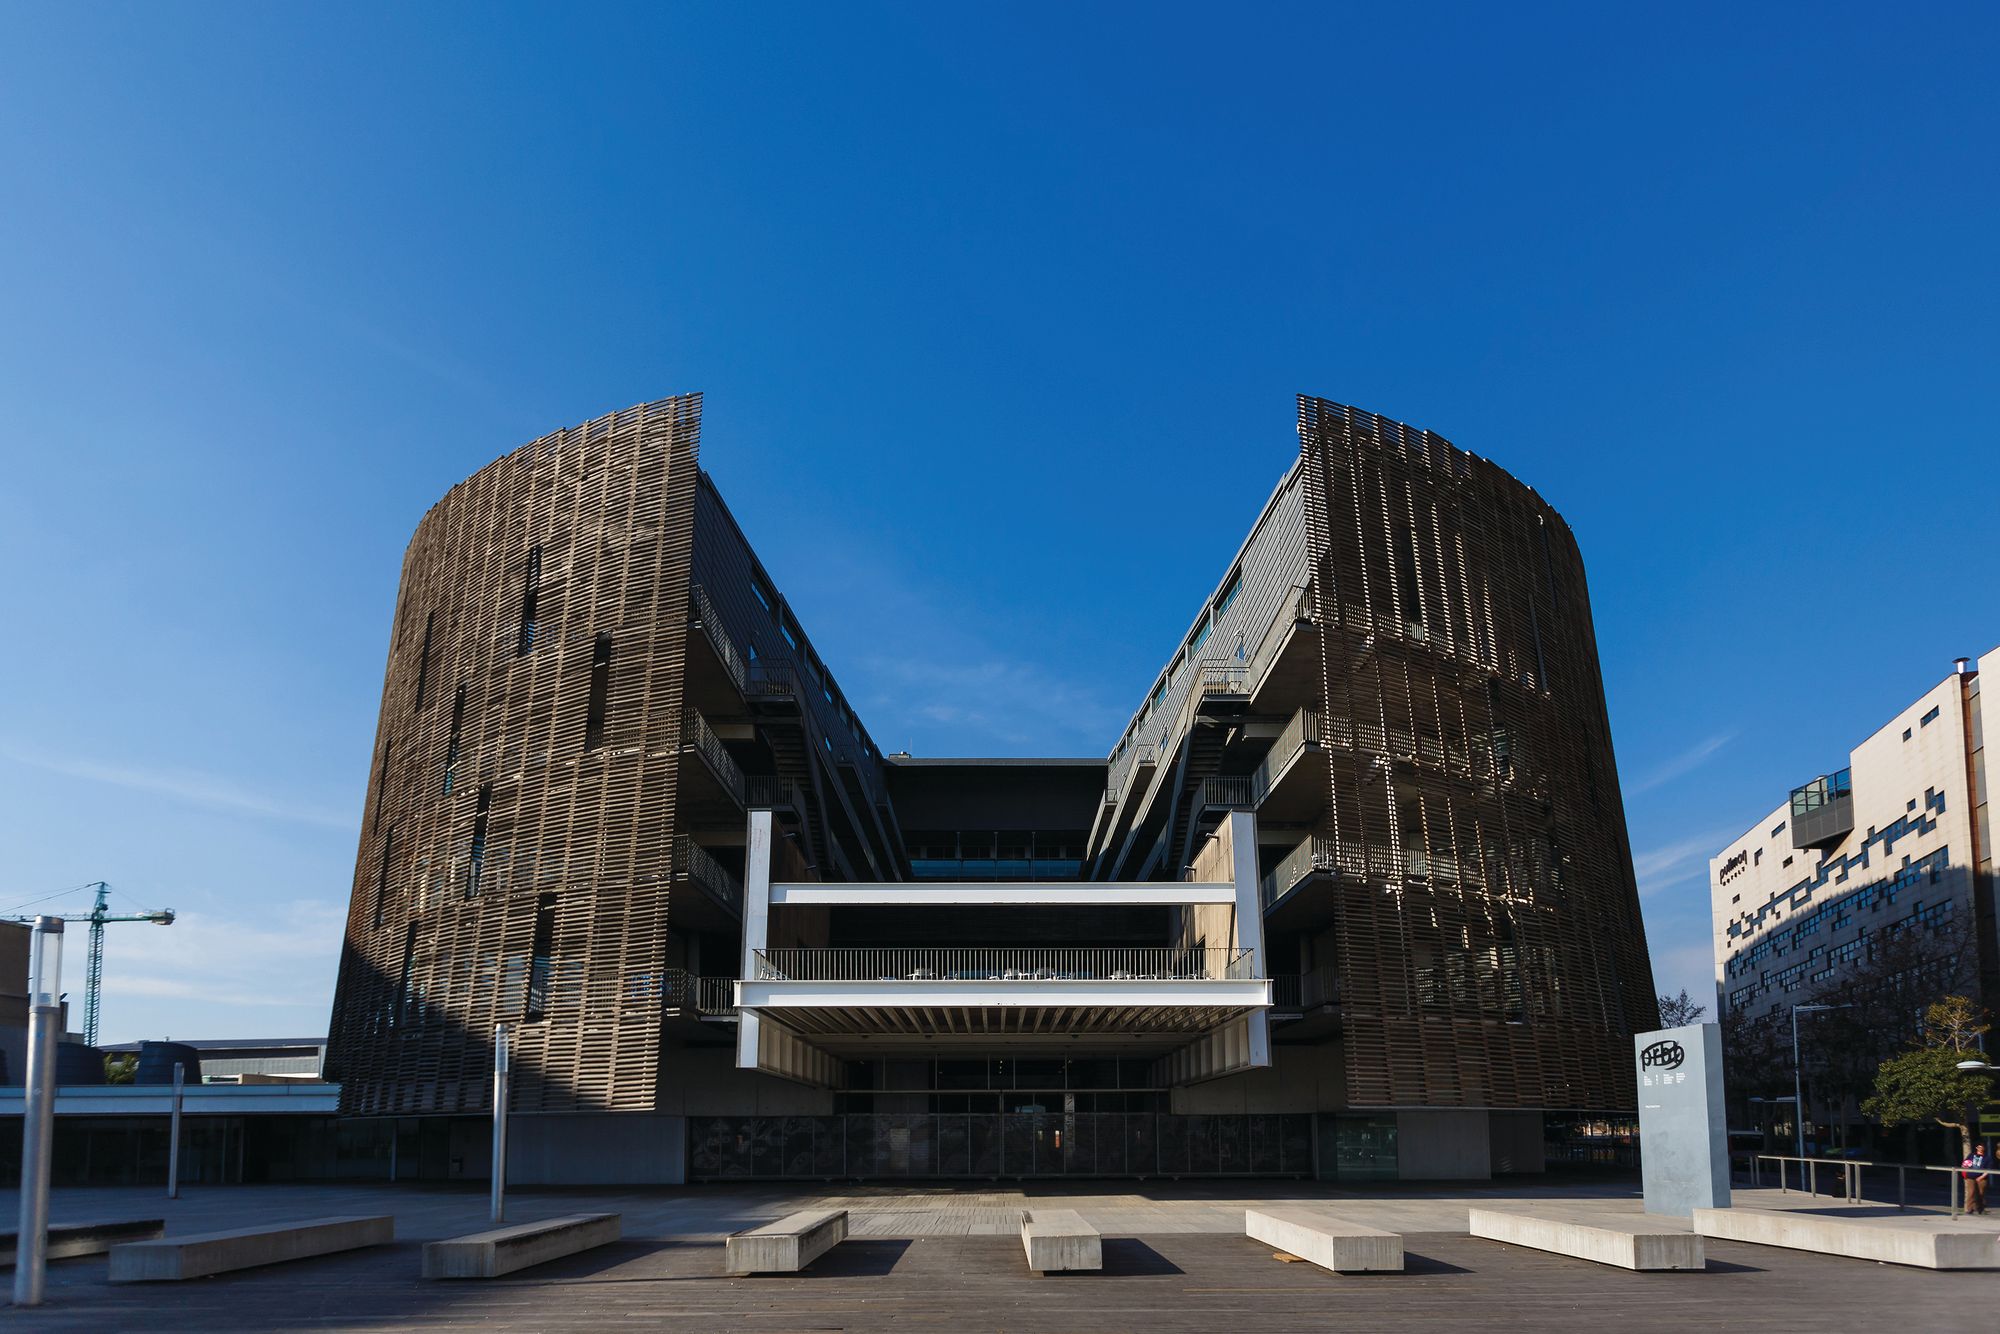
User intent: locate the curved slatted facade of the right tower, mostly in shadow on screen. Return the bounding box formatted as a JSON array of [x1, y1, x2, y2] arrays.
[[1298, 398, 1654, 1108]]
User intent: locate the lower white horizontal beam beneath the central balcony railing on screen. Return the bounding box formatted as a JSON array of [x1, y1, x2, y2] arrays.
[[736, 978, 1270, 1010]]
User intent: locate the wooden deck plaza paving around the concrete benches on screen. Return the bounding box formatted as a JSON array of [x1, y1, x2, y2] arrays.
[[0, 1182, 2000, 1334]]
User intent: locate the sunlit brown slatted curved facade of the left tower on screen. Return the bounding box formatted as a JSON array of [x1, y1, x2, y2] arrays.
[[330, 394, 700, 1114]]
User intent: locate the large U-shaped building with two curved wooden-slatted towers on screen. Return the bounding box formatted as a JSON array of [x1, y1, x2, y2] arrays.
[[328, 396, 1658, 1182]]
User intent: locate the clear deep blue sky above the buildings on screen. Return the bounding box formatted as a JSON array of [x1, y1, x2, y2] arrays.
[[0, 4, 2000, 1040]]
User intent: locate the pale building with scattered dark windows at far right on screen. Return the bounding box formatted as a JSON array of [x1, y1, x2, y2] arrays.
[[1708, 650, 2000, 1018]]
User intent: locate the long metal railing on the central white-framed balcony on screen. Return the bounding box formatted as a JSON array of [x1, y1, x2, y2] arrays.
[[756, 946, 1256, 982]]
